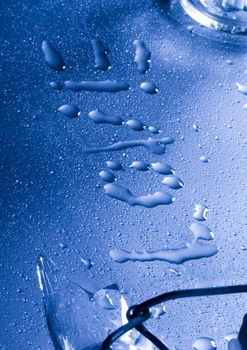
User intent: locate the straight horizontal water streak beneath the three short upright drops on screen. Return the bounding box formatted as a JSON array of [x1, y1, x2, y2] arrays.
[[64, 80, 130, 92]]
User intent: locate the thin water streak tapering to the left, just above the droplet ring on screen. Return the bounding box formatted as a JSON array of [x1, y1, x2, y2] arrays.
[[84, 136, 174, 154]]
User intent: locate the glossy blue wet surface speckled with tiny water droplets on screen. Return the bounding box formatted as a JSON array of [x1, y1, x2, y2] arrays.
[[0, 0, 247, 350]]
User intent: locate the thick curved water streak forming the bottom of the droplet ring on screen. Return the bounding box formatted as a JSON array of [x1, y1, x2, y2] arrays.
[[104, 184, 175, 208]]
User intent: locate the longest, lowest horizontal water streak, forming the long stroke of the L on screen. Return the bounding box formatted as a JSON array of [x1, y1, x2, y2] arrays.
[[110, 241, 218, 264]]
